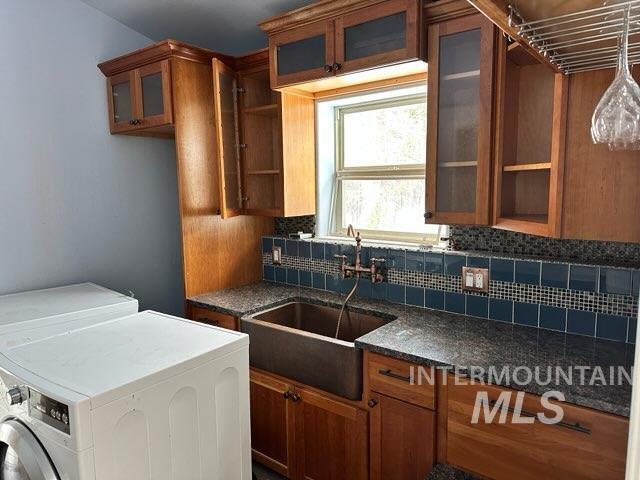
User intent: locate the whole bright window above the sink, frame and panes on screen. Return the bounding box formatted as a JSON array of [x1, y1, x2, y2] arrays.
[[318, 87, 440, 243]]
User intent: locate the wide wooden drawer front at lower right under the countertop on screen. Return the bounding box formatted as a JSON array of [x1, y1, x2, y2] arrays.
[[447, 382, 628, 480]]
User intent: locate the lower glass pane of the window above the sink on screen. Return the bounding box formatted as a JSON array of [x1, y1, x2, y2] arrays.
[[341, 178, 438, 234]]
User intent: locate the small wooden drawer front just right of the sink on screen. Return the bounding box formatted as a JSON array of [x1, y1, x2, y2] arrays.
[[367, 353, 435, 410]]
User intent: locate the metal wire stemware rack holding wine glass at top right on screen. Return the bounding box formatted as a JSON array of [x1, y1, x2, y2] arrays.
[[509, 0, 640, 74]]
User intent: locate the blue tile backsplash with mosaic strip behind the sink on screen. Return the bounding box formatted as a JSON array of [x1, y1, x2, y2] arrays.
[[262, 237, 640, 343]]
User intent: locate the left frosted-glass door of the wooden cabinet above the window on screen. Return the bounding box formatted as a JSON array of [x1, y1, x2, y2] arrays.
[[269, 20, 334, 88]]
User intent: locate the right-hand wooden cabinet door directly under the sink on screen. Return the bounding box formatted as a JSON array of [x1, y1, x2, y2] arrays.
[[295, 390, 368, 480]]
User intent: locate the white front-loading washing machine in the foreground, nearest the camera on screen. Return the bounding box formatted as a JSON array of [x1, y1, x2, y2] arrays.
[[0, 311, 251, 480]]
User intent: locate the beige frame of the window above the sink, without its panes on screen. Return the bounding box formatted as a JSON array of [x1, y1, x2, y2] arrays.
[[329, 93, 441, 245]]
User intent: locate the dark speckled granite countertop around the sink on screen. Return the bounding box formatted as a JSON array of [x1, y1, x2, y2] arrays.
[[188, 282, 634, 417]]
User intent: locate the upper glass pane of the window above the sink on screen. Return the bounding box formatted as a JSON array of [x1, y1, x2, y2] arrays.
[[343, 102, 427, 168]]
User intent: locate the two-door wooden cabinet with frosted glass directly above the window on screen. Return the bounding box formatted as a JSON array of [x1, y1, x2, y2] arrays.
[[260, 0, 423, 89]]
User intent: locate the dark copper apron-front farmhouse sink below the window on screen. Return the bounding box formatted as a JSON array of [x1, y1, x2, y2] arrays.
[[241, 302, 395, 400]]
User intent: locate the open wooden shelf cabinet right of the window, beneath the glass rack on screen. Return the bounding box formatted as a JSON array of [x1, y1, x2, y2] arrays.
[[493, 39, 568, 237]]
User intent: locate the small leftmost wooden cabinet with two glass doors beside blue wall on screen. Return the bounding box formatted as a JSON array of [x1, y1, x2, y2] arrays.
[[107, 60, 173, 133]]
